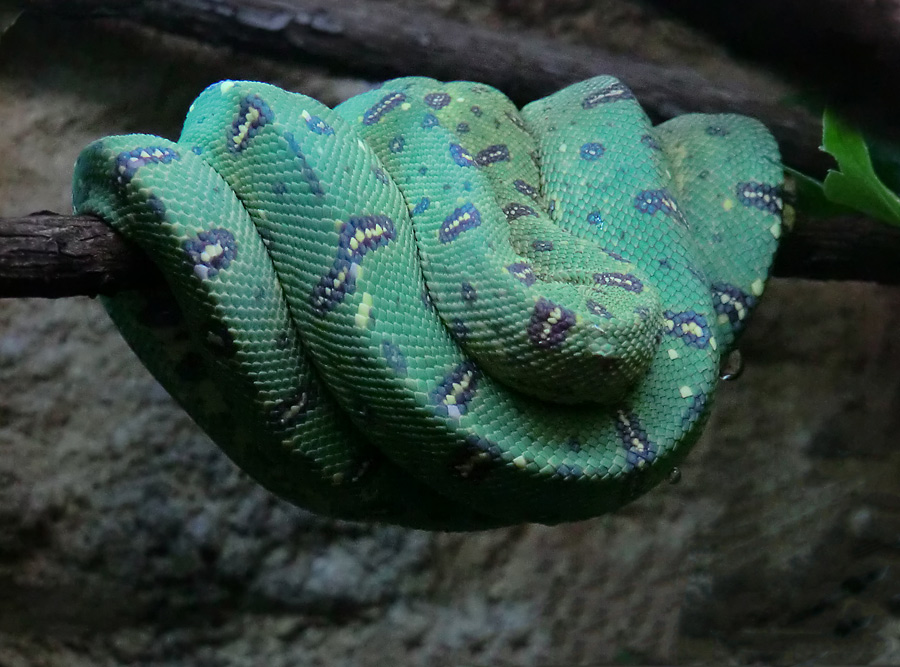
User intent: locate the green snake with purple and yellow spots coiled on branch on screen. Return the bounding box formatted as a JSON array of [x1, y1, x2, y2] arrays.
[[74, 76, 783, 530]]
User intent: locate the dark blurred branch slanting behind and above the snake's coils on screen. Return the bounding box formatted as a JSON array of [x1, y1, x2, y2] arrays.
[[19, 0, 829, 174]]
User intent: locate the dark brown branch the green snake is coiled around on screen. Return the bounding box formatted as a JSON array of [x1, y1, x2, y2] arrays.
[[0, 212, 900, 298]]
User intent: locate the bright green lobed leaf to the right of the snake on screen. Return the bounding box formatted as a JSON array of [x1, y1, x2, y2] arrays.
[[822, 109, 900, 225]]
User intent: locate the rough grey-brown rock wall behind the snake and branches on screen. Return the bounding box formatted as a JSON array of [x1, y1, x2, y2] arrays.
[[0, 0, 900, 667]]
